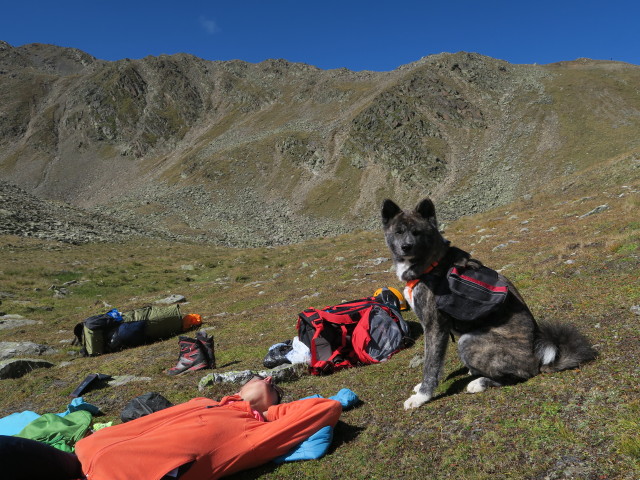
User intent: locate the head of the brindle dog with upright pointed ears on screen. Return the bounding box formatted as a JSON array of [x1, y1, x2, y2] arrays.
[[382, 198, 448, 281]]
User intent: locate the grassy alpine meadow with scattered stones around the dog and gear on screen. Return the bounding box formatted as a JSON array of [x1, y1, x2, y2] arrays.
[[0, 157, 640, 480]]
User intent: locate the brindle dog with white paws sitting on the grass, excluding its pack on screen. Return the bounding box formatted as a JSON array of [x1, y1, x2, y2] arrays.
[[381, 198, 596, 410]]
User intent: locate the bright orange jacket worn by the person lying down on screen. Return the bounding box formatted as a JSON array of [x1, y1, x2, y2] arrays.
[[76, 396, 342, 480]]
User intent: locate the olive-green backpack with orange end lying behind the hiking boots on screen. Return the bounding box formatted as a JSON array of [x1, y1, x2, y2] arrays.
[[73, 305, 202, 356]]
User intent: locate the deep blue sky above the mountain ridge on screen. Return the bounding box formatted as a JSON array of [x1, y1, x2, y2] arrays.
[[0, 0, 640, 71]]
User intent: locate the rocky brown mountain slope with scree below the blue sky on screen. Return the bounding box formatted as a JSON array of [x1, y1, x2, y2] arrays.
[[0, 42, 640, 245]]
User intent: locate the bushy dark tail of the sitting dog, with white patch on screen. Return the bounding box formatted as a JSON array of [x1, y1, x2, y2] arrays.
[[535, 322, 598, 373]]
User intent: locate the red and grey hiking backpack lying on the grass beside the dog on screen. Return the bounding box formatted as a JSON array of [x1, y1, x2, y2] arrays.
[[297, 296, 412, 375]]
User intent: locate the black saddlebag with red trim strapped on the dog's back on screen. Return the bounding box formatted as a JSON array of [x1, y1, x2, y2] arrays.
[[435, 266, 509, 321]]
